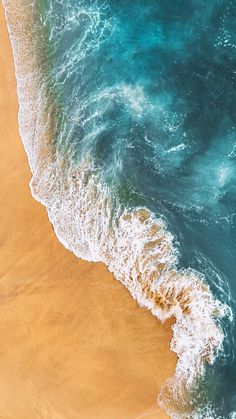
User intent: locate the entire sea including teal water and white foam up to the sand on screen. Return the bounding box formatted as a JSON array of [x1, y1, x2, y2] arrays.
[[4, 0, 236, 419]]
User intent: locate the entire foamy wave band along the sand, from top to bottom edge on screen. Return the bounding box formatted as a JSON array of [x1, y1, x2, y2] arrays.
[[3, 0, 230, 418]]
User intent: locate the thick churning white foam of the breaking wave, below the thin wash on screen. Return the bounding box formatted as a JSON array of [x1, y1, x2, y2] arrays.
[[31, 159, 225, 417]]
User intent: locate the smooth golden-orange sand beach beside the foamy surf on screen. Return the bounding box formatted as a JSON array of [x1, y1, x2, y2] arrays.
[[0, 6, 176, 419]]
